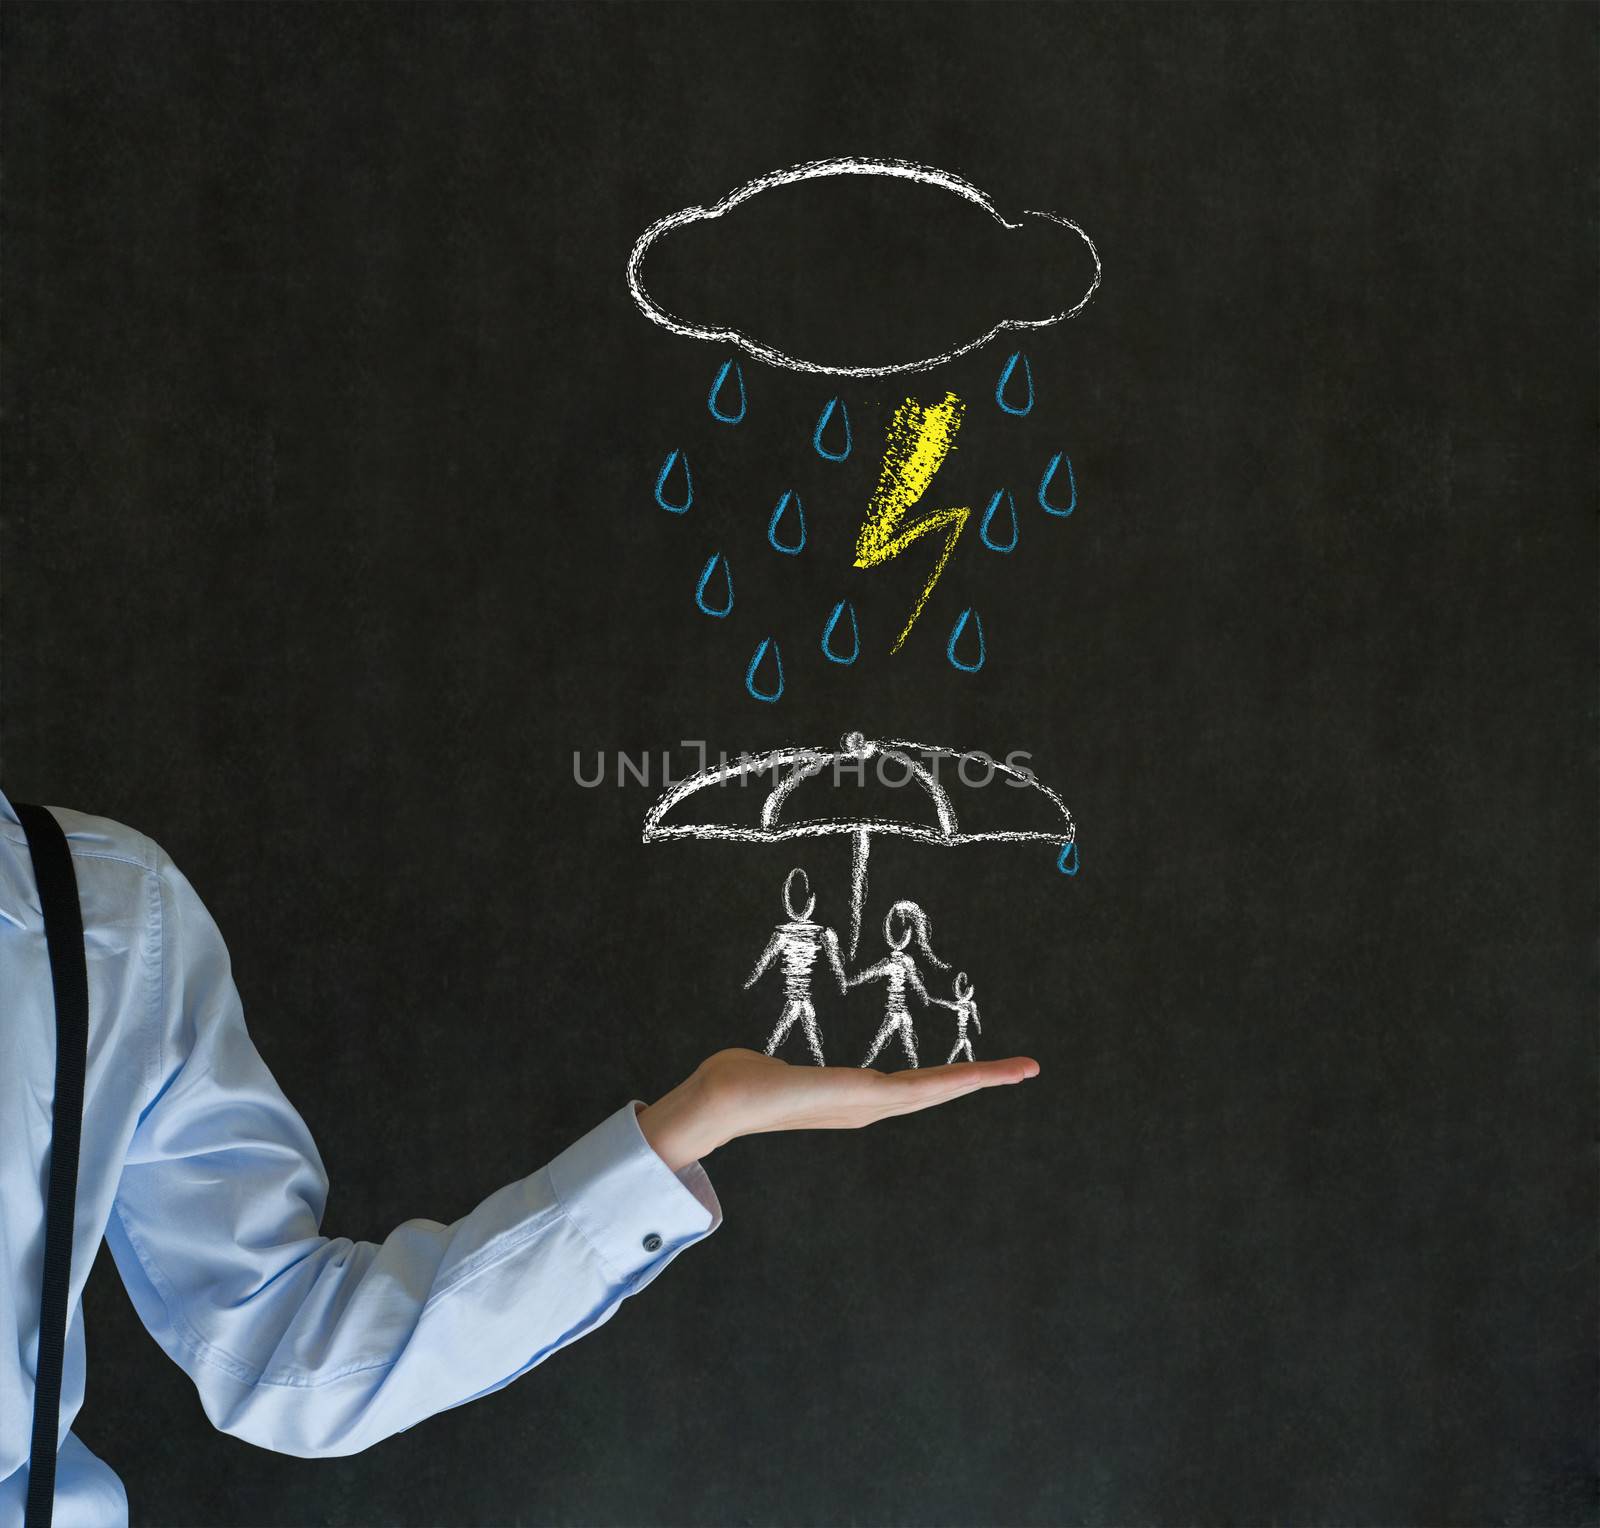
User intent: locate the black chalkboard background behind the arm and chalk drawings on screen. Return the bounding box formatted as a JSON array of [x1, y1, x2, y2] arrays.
[[0, 3, 1597, 1525]]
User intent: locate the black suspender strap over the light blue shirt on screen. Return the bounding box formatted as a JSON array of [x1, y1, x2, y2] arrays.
[[16, 805, 90, 1528]]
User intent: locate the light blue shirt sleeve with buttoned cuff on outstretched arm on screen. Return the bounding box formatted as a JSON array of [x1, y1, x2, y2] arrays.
[[107, 854, 722, 1456]]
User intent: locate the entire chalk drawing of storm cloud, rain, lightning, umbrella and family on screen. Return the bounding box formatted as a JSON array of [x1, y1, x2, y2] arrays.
[[626, 158, 1101, 1067]]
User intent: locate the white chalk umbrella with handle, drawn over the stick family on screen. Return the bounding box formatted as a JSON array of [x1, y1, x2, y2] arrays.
[[645, 733, 1077, 955]]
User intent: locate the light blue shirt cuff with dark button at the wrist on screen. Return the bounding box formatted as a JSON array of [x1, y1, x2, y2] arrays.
[[547, 1099, 722, 1283]]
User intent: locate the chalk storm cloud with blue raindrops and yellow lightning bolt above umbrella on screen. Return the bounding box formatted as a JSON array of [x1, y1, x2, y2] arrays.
[[626, 158, 1101, 691]]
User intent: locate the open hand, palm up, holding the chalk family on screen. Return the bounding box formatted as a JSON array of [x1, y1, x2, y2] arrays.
[[638, 1048, 1038, 1171]]
